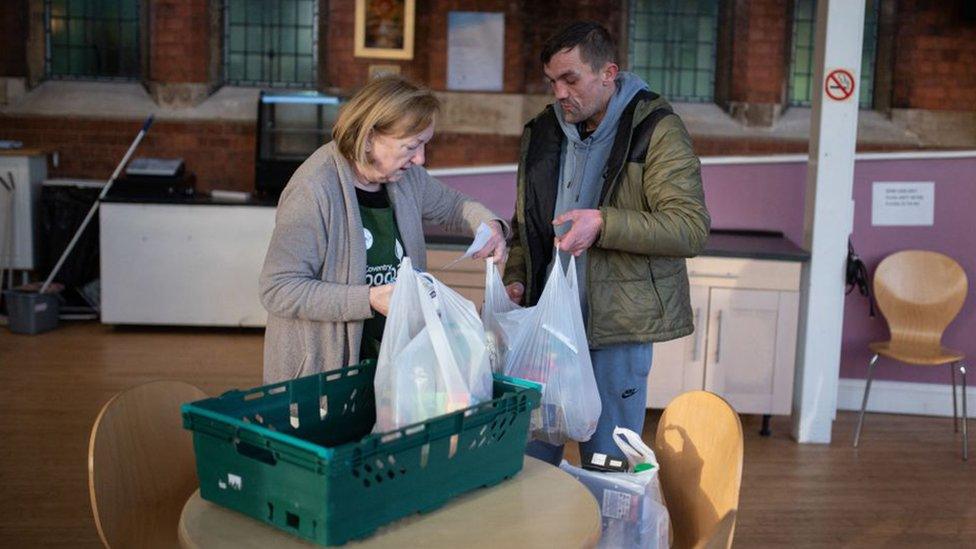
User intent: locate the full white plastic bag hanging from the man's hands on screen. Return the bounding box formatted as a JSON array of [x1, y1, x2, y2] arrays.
[[505, 251, 602, 444]]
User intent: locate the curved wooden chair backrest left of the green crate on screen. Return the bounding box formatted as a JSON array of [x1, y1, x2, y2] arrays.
[[88, 381, 207, 547]]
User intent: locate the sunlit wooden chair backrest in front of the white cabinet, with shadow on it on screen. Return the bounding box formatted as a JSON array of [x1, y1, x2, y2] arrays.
[[654, 391, 742, 548]]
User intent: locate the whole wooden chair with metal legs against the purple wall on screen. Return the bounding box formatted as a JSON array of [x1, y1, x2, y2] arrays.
[[854, 250, 969, 460]]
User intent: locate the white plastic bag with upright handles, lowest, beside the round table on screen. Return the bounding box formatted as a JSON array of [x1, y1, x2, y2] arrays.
[[559, 427, 671, 549]]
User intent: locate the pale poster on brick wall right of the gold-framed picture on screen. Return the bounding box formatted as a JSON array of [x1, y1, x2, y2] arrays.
[[447, 11, 505, 91]]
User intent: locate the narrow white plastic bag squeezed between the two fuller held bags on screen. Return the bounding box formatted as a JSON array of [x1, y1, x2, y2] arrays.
[[481, 258, 532, 373]]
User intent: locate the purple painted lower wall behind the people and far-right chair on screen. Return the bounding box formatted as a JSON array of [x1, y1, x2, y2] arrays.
[[442, 153, 976, 384]]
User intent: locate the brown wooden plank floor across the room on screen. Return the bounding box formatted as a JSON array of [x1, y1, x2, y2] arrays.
[[0, 322, 976, 549]]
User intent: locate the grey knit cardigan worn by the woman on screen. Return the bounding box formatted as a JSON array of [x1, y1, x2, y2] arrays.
[[259, 143, 508, 383]]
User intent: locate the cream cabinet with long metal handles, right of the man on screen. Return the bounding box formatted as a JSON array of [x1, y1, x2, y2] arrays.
[[647, 257, 800, 414]]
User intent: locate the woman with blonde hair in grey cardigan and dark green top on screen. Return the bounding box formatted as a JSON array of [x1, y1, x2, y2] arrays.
[[260, 77, 505, 383]]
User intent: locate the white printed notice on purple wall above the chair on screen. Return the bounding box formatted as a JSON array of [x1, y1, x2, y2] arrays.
[[871, 181, 935, 226]]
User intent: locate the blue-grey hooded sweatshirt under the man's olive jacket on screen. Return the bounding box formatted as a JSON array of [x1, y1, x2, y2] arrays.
[[549, 71, 647, 318]]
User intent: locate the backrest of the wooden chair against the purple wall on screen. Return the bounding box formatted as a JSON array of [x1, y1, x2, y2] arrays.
[[874, 250, 969, 351]]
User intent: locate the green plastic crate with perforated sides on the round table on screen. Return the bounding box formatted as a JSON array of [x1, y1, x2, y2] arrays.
[[182, 361, 540, 545]]
